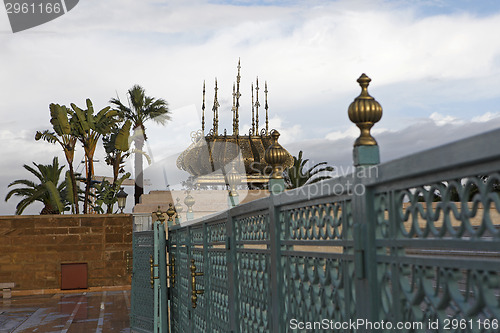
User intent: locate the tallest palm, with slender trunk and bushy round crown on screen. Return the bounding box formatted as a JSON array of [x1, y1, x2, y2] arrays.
[[110, 85, 170, 204]]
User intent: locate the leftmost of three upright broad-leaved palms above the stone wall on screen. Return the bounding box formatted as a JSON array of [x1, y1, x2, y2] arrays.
[[35, 104, 79, 214]]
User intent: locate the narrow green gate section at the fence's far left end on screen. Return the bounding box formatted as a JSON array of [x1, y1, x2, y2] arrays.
[[130, 222, 168, 333]]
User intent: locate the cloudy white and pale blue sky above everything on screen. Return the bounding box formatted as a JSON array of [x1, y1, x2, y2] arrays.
[[0, 0, 500, 215]]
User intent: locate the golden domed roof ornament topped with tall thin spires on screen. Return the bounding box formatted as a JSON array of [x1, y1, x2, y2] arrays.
[[177, 61, 293, 186]]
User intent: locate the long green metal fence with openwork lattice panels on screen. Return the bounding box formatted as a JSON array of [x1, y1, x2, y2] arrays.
[[168, 126, 500, 332]]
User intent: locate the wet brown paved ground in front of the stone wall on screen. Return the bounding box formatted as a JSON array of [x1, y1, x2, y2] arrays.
[[0, 290, 130, 333]]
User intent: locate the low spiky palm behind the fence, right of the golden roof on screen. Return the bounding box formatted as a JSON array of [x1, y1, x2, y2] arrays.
[[285, 150, 333, 189]]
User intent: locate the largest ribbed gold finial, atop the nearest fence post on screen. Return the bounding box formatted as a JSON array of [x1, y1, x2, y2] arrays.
[[348, 73, 382, 147]]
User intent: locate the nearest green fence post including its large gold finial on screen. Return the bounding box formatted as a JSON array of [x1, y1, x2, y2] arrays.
[[348, 74, 382, 332]]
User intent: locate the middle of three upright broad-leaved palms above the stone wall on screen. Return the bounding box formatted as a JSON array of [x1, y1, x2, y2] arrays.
[[70, 99, 118, 214]]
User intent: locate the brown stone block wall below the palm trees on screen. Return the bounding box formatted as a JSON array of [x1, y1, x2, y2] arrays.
[[0, 214, 132, 290]]
